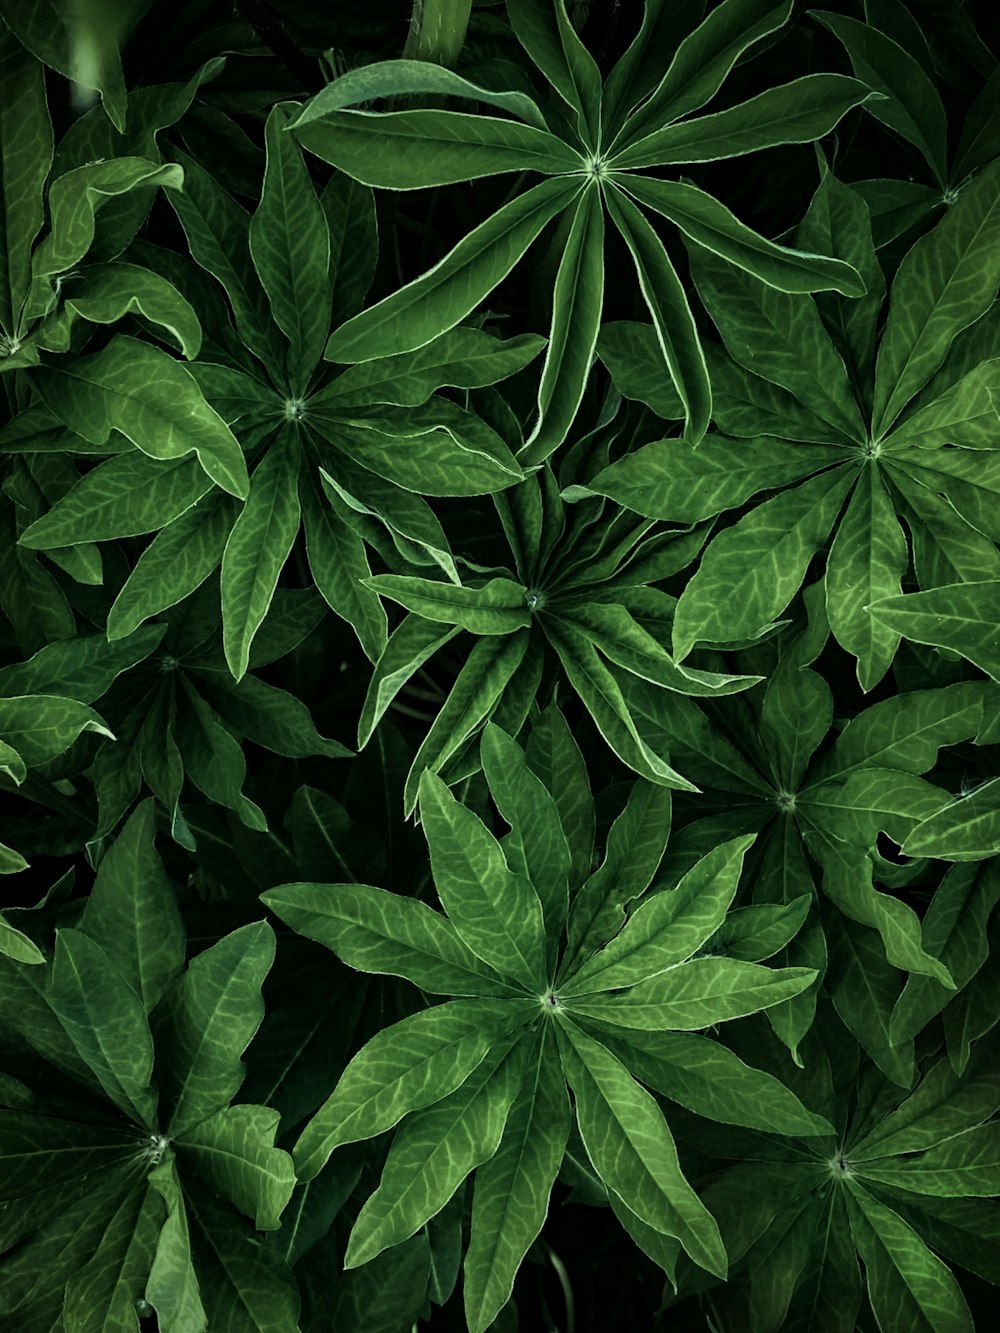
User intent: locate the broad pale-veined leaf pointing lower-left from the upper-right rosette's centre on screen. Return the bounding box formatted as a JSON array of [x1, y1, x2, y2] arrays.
[[673, 467, 853, 661]]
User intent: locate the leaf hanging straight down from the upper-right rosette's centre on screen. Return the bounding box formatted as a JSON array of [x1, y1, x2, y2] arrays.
[[825, 463, 907, 692]]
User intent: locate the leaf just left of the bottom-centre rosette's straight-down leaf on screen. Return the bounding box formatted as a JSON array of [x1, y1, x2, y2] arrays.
[[344, 1040, 525, 1268]]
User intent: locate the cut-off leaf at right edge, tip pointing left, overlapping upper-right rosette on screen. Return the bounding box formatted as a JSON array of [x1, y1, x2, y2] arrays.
[[871, 580, 1000, 681]]
